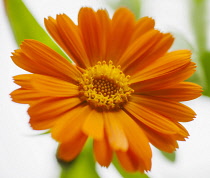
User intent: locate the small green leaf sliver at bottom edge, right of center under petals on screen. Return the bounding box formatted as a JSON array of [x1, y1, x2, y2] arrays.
[[112, 157, 149, 178]]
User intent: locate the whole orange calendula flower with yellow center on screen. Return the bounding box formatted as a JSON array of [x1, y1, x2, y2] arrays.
[[11, 8, 201, 172]]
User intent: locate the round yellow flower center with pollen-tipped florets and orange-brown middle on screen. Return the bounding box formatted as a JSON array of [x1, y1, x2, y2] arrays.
[[79, 61, 134, 110]]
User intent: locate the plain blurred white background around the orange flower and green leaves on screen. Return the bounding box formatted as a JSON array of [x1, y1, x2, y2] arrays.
[[0, 0, 210, 178]]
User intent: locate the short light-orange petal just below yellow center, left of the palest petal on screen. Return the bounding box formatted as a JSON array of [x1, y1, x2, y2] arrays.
[[82, 110, 104, 140]]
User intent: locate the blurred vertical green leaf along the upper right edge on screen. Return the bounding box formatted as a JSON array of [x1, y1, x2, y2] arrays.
[[189, 0, 210, 96]]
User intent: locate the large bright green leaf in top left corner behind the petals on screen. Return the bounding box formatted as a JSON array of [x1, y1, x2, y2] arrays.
[[4, 0, 68, 59]]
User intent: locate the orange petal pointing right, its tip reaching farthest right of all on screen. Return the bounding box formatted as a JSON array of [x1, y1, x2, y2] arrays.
[[141, 82, 202, 101]]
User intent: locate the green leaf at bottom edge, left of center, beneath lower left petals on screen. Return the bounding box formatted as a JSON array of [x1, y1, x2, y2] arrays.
[[58, 140, 99, 178]]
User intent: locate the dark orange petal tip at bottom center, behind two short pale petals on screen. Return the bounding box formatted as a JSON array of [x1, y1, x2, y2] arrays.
[[93, 135, 113, 167]]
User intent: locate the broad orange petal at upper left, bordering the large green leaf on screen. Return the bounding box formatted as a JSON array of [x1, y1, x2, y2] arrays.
[[12, 40, 80, 82]]
